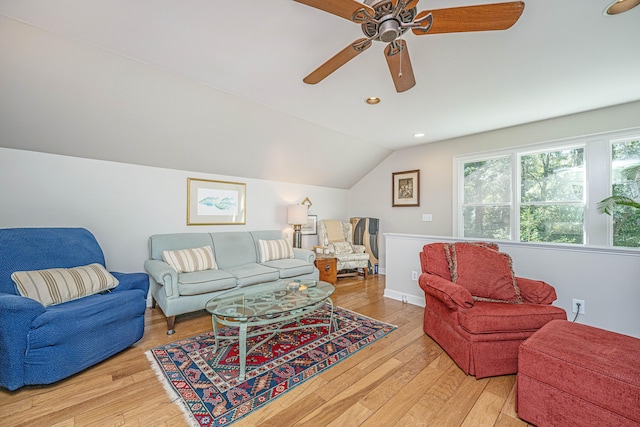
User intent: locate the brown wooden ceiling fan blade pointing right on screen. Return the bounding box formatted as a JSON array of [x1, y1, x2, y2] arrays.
[[412, 1, 524, 35]]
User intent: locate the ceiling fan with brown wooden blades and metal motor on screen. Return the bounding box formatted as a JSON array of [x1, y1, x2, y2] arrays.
[[295, 0, 524, 92]]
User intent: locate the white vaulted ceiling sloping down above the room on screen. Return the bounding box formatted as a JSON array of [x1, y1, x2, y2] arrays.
[[0, 0, 640, 188]]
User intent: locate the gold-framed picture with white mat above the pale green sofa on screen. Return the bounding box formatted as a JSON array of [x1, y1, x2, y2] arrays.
[[187, 178, 247, 225]]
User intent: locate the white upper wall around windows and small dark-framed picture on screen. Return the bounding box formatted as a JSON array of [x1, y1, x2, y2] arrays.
[[349, 100, 640, 271]]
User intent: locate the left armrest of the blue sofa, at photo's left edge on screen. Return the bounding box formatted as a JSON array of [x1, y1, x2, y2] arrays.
[[0, 294, 45, 390]]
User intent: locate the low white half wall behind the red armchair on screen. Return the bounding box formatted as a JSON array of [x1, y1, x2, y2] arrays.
[[384, 233, 640, 338]]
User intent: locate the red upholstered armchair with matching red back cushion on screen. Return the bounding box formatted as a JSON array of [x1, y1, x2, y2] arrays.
[[419, 242, 567, 378]]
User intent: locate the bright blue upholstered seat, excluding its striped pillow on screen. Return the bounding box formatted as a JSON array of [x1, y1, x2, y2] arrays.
[[0, 228, 149, 390]]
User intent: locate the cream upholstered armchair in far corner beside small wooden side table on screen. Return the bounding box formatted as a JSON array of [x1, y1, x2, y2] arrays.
[[318, 219, 369, 278]]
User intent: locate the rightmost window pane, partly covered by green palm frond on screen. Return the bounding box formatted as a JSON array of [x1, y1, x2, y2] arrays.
[[611, 139, 640, 247]]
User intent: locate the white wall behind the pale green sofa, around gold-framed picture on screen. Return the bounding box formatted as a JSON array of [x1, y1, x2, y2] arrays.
[[0, 148, 348, 272]]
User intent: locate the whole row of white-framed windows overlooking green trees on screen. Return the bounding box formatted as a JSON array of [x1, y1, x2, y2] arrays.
[[455, 129, 640, 247]]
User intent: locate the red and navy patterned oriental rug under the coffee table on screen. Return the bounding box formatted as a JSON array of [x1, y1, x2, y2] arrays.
[[146, 305, 396, 427]]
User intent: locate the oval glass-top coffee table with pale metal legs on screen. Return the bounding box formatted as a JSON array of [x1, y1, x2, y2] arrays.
[[205, 280, 336, 381]]
